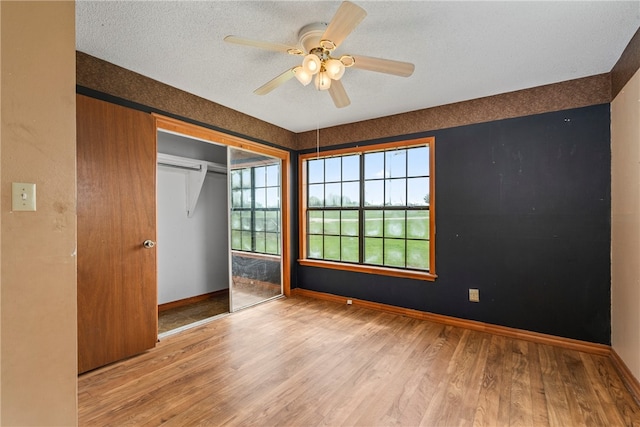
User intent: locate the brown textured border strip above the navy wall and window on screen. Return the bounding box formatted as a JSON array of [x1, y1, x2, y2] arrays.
[[296, 73, 611, 150]]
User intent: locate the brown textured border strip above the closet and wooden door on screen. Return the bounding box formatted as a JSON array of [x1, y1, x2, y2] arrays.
[[76, 51, 296, 149]]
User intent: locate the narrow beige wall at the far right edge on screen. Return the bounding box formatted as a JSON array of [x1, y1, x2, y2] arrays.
[[611, 67, 640, 380]]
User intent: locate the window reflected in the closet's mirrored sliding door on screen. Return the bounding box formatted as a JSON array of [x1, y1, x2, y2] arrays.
[[231, 164, 280, 255]]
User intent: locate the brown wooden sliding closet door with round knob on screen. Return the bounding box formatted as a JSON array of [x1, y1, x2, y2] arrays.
[[77, 95, 158, 373]]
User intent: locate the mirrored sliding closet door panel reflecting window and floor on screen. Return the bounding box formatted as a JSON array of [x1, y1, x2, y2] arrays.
[[228, 147, 282, 311]]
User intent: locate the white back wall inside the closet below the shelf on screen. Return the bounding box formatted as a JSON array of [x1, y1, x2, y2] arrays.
[[157, 166, 229, 304]]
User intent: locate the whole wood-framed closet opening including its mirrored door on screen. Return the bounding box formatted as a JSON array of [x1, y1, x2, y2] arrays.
[[156, 116, 289, 338]]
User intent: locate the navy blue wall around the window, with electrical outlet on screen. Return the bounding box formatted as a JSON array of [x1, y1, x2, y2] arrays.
[[293, 104, 611, 344]]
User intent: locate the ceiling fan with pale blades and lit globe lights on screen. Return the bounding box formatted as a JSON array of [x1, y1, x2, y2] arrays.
[[224, 1, 415, 108]]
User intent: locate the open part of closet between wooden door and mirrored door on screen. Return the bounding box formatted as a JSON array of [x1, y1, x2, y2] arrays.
[[156, 131, 230, 336]]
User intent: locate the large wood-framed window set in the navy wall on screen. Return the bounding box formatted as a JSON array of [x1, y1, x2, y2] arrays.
[[300, 138, 435, 280]]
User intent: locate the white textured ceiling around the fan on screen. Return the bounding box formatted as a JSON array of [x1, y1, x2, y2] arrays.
[[76, 0, 640, 132]]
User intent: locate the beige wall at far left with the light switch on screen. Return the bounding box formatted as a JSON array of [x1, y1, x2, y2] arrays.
[[0, 1, 77, 426]]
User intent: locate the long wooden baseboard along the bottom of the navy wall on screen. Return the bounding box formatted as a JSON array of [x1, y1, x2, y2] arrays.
[[291, 288, 611, 356]]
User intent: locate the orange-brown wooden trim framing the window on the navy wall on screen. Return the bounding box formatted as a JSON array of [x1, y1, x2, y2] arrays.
[[298, 137, 438, 281]]
